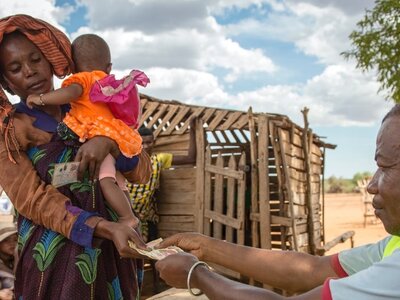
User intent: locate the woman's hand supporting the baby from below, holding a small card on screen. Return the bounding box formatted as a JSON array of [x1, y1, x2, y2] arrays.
[[75, 136, 119, 180]]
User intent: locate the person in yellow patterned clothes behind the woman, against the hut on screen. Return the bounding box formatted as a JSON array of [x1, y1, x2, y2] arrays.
[[128, 118, 197, 241]]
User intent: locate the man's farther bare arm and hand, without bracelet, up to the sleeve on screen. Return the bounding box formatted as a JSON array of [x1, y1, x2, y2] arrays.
[[159, 233, 337, 292]]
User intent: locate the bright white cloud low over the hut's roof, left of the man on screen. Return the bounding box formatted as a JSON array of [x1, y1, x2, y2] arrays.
[[194, 65, 392, 126]]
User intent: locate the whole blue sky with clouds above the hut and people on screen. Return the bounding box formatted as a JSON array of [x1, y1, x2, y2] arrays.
[[0, 0, 392, 178]]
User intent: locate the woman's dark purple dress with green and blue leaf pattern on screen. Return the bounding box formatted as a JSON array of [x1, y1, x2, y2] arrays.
[[15, 123, 143, 300]]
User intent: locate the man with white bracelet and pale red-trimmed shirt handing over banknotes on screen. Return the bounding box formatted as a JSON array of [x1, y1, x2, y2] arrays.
[[156, 104, 400, 300]]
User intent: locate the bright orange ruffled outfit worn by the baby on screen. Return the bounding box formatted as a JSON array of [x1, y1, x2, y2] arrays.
[[62, 71, 142, 157]]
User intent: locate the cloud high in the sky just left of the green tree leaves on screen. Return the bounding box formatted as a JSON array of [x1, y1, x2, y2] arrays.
[[225, 2, 361, 64]]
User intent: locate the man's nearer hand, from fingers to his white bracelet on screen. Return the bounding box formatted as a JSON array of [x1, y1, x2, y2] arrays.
[[156, 253, 198, 288]]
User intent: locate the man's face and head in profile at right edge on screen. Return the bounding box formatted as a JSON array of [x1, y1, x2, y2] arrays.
[[368, 116, 400, 235]]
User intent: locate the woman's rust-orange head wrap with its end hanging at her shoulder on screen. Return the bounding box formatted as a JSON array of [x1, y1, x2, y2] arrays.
[[0, 15, 74, 162]]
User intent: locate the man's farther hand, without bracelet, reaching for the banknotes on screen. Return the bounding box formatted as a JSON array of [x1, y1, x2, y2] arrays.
[[156, 233, 212, 260]]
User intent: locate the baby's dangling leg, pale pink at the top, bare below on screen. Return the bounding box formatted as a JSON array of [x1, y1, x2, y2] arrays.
[[99, 155, 139, 227]]
